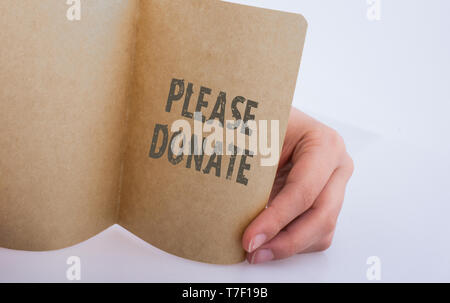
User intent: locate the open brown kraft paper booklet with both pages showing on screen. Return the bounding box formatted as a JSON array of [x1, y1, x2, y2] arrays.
[[0, 0, 307, 264]]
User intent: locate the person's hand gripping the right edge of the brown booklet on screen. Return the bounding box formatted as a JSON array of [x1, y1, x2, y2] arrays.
[[242, 108, 353, 264]]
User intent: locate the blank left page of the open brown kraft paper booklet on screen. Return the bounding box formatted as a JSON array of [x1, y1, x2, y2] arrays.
[[0, 0, 137, 250]]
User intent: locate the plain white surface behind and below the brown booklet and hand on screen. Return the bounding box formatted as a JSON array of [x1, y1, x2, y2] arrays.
[[0, 0, 450, 282]]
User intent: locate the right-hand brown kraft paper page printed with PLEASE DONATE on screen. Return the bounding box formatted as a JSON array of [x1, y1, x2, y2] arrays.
[[119, 0, 306, 264]]
